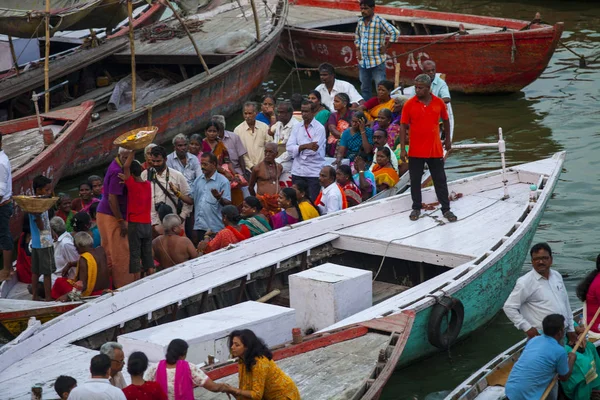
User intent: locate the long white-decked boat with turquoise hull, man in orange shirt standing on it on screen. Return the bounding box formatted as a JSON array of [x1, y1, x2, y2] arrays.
[[0, 152, 565, 398]]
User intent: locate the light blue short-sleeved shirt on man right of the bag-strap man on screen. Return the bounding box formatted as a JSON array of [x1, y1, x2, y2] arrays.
[[190, 171, 231, 232]]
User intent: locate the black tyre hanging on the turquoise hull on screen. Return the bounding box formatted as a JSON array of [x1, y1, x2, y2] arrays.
[[427, 296, 465, 350]]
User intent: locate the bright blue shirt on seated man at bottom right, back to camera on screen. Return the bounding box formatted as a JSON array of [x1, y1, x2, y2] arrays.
[[505, 335, 569, 400]]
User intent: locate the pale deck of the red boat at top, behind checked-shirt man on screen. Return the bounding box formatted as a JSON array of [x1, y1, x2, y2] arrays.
[[287, 5, 506, 33]]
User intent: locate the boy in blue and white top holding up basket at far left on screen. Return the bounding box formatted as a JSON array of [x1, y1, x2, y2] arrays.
[[29, 175, 56, 301]]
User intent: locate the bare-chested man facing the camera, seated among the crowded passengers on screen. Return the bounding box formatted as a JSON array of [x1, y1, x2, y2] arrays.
[[248, 143, 283, 219]]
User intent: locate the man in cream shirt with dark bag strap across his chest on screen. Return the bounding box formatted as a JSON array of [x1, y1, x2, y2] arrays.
[[142, 146, 192, 237]]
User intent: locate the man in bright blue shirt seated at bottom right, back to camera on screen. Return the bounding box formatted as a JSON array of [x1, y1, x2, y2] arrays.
[[505, 314, 577, 400]]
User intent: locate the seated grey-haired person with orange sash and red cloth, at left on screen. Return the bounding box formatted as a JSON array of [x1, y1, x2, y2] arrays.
[[52, 232, 110, 301]]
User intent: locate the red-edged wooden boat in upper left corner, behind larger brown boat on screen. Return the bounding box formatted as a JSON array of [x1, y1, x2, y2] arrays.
[[0, 1, 166, 106]]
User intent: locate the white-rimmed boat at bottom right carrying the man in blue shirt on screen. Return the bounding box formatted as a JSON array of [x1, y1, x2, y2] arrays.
[[445, 309, 584, 400]]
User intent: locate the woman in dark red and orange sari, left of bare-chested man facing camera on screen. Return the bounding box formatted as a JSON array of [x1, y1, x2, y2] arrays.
[[203, 121, 248, 206]]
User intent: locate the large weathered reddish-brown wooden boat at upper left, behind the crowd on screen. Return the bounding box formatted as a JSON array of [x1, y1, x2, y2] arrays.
[[58, 0, 287, 177]]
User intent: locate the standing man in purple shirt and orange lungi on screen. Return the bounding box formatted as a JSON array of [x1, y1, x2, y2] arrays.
[[96, 147, 134, 288]]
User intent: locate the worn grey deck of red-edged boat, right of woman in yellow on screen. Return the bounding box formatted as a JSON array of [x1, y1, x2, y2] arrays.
[[202, 332, 390, 400]]
